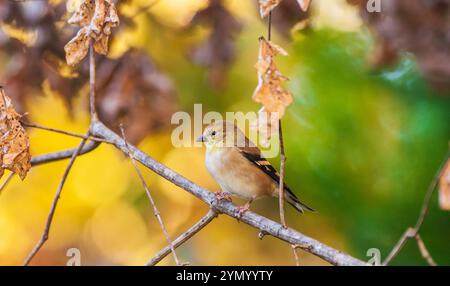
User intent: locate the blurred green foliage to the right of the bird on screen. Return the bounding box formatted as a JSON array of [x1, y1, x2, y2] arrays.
[[285, 31, 450, 265]]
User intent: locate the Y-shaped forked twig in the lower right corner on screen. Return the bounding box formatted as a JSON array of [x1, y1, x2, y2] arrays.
[[383, 151, 450, 265]]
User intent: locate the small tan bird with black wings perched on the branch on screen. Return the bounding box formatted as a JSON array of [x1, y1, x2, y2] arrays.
[[197, 120, 314, 215]]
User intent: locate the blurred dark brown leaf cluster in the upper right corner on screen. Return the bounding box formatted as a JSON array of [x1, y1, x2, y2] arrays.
[[347, 0, 450, 90]]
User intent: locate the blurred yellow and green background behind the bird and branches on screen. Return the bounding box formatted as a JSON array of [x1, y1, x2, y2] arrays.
[[0, 0, 450, 265]]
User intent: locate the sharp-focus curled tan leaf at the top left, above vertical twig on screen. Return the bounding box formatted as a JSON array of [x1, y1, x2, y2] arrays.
[[64, 0, 119, 66]]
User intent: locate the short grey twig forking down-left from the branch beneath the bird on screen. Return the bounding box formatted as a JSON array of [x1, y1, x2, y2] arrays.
[[145, 210, 217, 266]]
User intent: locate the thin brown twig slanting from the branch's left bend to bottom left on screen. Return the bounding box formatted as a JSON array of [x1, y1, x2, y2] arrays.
[[23, 135, 89, 266]]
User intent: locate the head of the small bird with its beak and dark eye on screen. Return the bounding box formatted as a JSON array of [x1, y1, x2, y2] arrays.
[[197, 120, 245, 147]]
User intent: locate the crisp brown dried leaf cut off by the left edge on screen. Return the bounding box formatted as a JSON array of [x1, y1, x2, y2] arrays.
[[0, 88, 31, 180]]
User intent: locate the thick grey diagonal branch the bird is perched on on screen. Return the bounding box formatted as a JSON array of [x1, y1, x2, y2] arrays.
[[91, 121, 368, 266]]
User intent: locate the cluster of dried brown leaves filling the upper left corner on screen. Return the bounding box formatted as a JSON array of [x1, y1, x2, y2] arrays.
[[0, 0, 176, 143]]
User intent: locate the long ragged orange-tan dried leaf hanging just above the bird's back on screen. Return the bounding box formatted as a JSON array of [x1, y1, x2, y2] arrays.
[[252, 37, 292, 145]]
